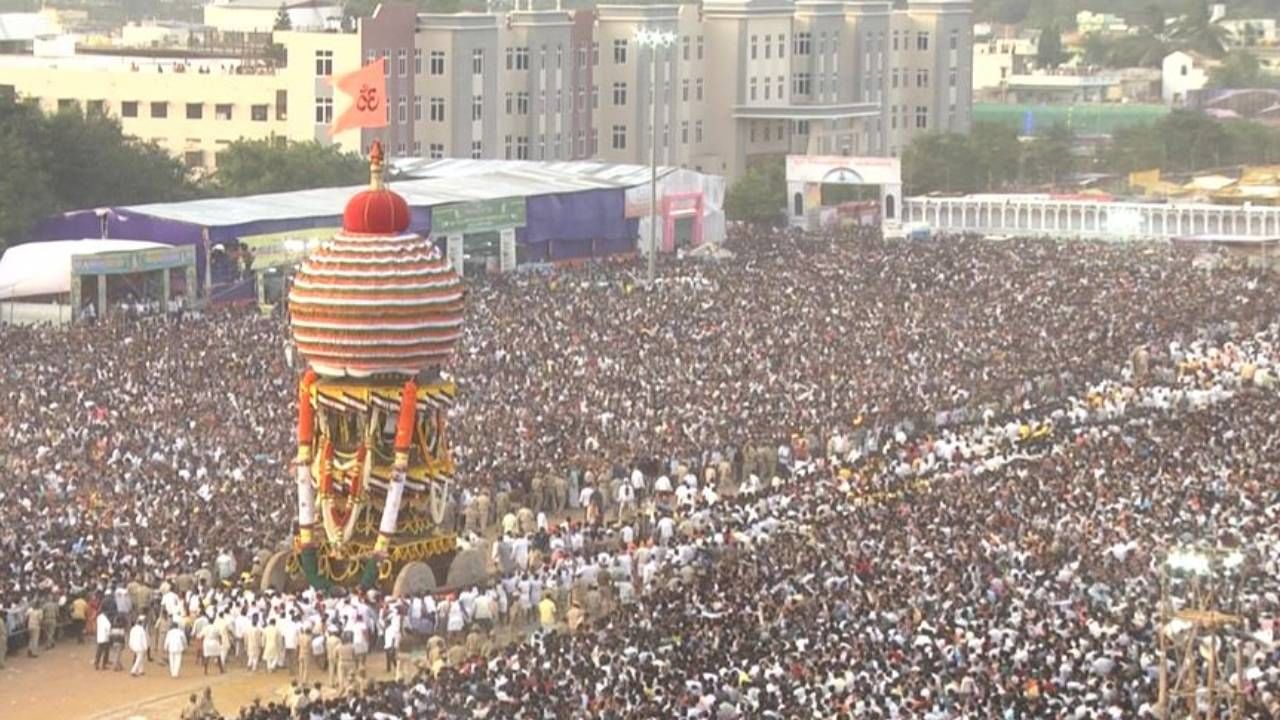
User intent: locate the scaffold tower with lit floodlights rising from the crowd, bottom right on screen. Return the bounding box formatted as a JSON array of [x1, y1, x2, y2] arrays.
[[1157, 547, 1248, 720]]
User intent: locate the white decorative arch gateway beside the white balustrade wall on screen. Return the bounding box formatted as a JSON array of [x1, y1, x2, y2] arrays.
[[787, 155, 902, 229]]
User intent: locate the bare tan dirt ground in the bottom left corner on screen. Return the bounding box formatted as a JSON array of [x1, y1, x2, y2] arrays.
[[0, 635, 407, 720]]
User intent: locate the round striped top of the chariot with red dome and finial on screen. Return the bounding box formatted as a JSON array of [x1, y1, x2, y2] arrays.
[[289, 142, 463, 378]]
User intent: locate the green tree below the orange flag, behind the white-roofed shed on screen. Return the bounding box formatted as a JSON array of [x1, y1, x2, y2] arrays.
[[209, 138, 369, 196]]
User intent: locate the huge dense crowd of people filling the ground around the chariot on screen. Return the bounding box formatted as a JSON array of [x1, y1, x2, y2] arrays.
[[0, 229, 1280, 720]]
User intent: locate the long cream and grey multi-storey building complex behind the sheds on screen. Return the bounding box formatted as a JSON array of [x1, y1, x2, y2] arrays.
[[0, 0, 973, 178]]
